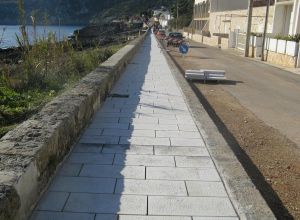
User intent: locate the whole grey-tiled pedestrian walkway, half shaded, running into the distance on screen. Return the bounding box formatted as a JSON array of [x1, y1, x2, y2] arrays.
[[31, 35, 238, 220]]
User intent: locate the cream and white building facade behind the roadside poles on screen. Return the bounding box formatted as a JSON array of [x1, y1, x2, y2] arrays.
[[192, 0, 300, 35]]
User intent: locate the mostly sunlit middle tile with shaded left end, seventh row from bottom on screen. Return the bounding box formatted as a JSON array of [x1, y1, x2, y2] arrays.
[[120, 137, 170, 146]]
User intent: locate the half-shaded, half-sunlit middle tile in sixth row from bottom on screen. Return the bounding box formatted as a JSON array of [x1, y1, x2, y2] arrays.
[[102, 145, 153, 155]]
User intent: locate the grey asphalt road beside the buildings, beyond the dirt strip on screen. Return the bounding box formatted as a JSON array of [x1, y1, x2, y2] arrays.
[[172, 42, 300, 147]]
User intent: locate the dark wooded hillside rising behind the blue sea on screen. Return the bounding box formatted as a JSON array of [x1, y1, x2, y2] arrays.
[[0, 0, 174, 24]]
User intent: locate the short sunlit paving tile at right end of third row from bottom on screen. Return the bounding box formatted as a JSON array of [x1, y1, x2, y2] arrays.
[[186, 181, 228, 197]]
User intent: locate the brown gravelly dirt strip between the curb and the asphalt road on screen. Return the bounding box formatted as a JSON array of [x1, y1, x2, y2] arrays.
[[169, 44, 300, 219]]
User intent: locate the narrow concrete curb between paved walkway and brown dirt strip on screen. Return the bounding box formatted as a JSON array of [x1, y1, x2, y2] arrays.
[[159, 40, 276, 220]]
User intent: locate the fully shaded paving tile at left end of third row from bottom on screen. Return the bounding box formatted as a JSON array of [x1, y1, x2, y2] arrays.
[[49, 176, 116, 193]]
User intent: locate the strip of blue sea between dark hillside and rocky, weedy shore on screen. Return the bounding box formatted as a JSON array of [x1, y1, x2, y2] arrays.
[[0, 25, 82, 49]]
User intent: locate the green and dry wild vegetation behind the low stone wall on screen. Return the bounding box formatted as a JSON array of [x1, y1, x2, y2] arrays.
[[0, 0, 122, 137]]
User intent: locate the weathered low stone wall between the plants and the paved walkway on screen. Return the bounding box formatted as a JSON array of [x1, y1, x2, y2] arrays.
[[0, 30, 147, 220]]
